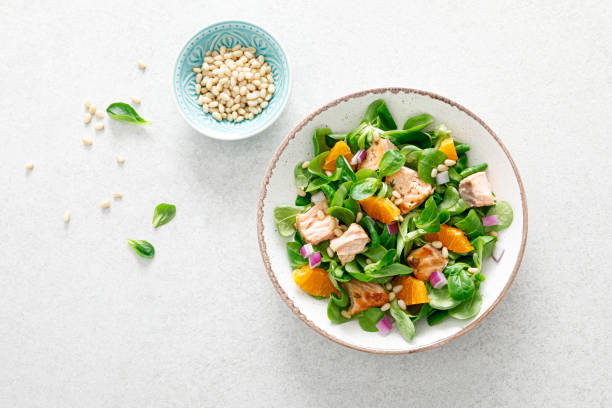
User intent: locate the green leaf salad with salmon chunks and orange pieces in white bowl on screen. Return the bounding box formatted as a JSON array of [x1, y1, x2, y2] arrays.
[[274, 100, 513, 341]]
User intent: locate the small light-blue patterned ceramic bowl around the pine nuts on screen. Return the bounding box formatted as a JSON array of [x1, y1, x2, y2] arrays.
[[172, 21, 291, 140]]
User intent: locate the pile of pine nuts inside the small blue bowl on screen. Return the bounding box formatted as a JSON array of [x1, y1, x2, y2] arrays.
[[193, 45, 274, 122]]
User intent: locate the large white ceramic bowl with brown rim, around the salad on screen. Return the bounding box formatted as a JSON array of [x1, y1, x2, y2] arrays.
[[257, 88, 527, 353]]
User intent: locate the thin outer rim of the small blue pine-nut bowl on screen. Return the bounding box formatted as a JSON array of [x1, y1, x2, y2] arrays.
[[171, 20, 292, 140]]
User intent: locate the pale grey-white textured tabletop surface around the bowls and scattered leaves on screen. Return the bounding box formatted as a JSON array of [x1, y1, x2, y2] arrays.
[[0, 0, 612, 407]]
